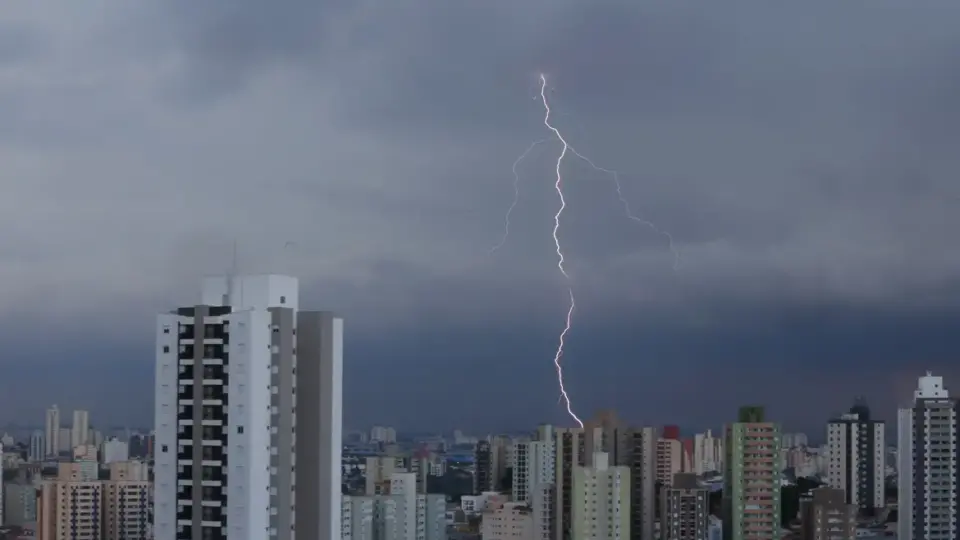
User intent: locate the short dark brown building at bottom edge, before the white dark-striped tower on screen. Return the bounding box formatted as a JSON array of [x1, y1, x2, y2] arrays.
[[800, 487, 858, 540]]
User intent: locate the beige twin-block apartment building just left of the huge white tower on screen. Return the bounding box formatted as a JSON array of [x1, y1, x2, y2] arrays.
[[36, 462, 151, 540]]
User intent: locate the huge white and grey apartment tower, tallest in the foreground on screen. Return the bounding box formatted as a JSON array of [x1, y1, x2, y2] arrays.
[[154, 275, 343, 540]]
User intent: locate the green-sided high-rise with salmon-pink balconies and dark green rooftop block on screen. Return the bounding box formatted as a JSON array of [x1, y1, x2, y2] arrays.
[[722, 407, 782, 540]]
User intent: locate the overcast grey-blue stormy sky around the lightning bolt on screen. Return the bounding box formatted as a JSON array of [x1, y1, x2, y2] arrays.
[[0, 0, 960, 430]]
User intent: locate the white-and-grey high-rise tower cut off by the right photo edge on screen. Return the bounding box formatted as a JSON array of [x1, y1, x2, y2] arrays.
[[897, 373, 960, 540]]
